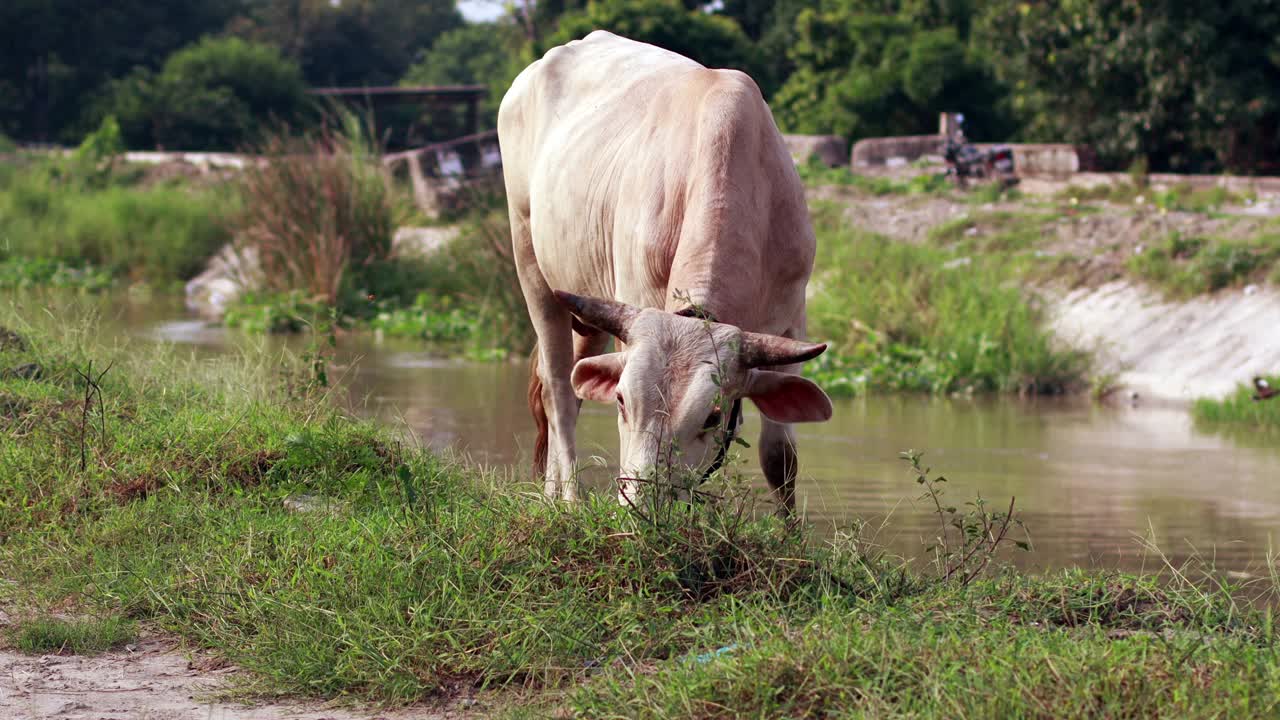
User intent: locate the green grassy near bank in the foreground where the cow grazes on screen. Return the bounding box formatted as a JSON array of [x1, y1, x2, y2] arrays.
[[0, 313, 1280, 717]]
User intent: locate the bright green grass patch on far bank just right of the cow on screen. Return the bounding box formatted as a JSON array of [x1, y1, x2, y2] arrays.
[[805, 204, 1088, 393]]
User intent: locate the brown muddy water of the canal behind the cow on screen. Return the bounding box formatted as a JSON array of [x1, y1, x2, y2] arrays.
[[35, 292, 1280, 575]]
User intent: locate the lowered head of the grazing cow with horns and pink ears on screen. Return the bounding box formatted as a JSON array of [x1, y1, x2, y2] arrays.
[[556, 291, 831, 501]]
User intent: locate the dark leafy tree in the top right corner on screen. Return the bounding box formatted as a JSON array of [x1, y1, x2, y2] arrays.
[[979, 0, 1280, 172]]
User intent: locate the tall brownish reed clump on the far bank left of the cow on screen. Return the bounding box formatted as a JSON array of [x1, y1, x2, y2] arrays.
[[237, 115, 399, 306]]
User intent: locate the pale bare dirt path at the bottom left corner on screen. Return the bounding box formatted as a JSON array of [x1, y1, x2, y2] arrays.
[[0, 638, 463, 720]]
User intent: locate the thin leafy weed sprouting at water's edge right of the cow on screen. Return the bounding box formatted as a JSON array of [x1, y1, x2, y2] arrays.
[[899, 450, 1030, 585]]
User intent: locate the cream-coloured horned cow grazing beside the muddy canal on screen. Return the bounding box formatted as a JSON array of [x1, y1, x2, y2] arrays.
[[498, 31, 832, 509]]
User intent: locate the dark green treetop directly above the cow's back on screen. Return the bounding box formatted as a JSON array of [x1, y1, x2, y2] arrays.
[[539, 0, 760, 76]]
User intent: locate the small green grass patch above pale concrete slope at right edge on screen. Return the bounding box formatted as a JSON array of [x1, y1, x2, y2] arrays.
[[1128, 233, 1280, 297]]
